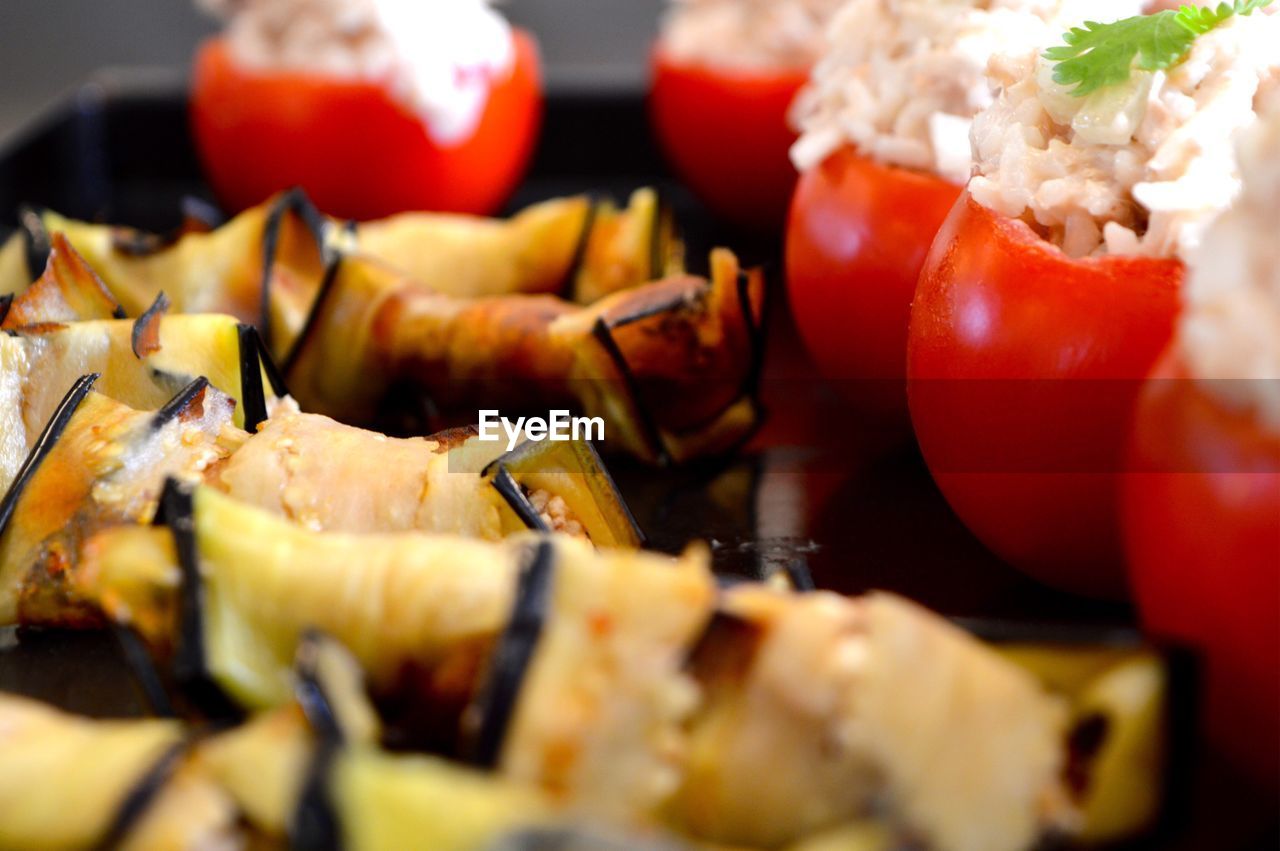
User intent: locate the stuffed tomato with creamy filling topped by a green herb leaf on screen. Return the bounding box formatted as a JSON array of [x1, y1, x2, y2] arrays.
[[908, 3, 1280, 596]]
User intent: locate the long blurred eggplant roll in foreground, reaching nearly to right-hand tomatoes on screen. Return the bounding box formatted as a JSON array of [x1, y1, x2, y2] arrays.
[[77, 489, 1165, 851]]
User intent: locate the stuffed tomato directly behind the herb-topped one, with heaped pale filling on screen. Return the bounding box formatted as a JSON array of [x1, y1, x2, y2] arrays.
[[786, 0, 1135, 429]]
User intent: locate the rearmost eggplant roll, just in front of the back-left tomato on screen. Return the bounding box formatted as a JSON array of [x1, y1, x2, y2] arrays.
[[0, 189, 684, 357]]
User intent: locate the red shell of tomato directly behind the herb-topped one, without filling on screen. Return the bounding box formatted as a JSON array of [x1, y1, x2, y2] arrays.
[[786, 147, 960, 427]]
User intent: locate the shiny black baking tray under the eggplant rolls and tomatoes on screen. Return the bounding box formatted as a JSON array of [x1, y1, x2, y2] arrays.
[[0, 73, 1277, 848]]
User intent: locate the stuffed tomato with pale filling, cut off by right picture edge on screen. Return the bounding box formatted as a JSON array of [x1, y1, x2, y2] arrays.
[[1123, 109, 1280, 795]]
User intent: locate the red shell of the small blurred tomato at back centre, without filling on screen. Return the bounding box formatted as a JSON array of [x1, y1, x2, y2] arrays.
[[649, 46, 809, 230]]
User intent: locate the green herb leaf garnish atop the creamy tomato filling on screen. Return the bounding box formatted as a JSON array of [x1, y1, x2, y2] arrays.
[[1044, 0, 1271, 97]]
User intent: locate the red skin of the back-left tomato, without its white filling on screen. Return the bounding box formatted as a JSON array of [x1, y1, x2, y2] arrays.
[[191, 31, 543, 220]]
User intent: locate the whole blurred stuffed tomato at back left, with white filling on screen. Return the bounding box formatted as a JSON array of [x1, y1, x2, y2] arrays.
[[191, 0, 543, 220]]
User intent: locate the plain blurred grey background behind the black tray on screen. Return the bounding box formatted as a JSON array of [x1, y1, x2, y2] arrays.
[[0, 0, 664, 137]]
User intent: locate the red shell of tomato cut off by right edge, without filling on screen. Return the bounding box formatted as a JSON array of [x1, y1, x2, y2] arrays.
[[1123, 352, 1280, 790]]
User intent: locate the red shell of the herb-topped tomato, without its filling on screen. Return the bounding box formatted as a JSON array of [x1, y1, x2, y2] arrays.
[[908, 193, 1183, 596]]
